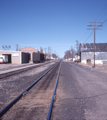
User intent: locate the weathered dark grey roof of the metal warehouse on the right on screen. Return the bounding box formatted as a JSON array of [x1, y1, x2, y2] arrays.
[[79, 43, 107, 52]]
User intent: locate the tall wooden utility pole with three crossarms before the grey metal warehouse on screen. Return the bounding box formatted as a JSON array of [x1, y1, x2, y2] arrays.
[[87, 21, 102, 67]]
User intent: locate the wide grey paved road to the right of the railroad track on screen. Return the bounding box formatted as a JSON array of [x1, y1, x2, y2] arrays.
[[52, 62, 107, 120]]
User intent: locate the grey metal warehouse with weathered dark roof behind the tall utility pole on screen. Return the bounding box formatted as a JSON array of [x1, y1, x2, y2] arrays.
[[79, 43, 107, 64]]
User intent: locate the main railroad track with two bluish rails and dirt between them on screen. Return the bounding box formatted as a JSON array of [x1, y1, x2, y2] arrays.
[[0, 62, 61, 120]]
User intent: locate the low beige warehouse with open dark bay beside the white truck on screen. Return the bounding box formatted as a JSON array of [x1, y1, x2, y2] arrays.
[[0, 50, 30, 64]]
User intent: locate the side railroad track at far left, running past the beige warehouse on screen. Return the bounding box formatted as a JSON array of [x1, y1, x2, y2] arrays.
[[0, 62, 56, 79]]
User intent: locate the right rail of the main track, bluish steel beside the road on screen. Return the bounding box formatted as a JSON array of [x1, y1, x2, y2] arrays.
[[46, 64, 61, 120]]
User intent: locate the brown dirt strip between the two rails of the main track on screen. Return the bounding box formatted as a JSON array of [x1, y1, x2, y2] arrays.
[[3, 62, 59, 120]]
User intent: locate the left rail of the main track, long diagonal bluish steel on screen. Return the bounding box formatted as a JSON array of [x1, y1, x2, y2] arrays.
[[0, 62, 59, 119]]
